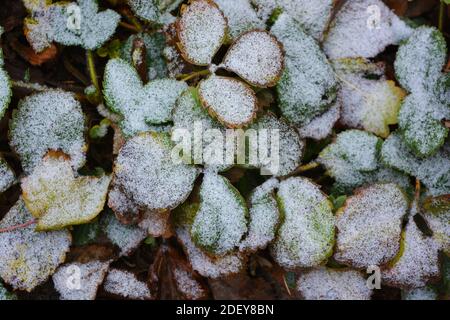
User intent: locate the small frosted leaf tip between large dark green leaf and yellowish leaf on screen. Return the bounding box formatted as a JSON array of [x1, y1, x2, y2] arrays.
[[298, 100, 342, 140]]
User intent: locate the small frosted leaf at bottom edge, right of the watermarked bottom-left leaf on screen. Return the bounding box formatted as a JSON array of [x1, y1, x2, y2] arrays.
[[103, 269, 152, 300]]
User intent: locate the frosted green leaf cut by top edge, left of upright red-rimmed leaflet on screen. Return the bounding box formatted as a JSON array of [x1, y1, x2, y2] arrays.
[[127, 0, 182, 25]]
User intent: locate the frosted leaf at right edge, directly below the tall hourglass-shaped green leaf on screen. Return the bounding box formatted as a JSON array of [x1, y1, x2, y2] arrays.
[[381, 132, 450, 196]]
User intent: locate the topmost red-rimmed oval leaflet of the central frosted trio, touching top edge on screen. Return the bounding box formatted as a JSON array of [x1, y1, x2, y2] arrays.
[[177, 0, 228, 65]]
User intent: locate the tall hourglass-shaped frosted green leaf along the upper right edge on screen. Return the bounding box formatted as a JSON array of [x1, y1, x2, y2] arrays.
[[395, 27, 450, 157]]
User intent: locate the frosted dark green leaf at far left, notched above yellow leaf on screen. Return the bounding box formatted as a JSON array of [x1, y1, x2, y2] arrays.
[[9, 90, 87, 173]]
